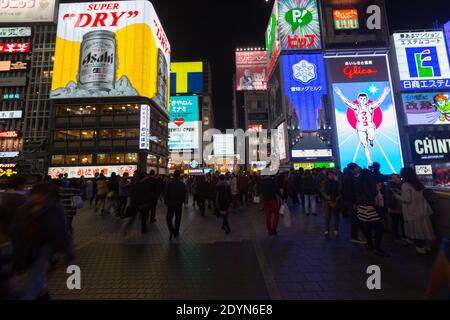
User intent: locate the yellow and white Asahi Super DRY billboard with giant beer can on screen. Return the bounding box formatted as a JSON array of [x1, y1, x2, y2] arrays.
[[50, 1, 171, 110]]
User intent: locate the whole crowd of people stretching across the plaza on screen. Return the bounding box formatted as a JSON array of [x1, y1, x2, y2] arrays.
[[0, 163, 446, 299]]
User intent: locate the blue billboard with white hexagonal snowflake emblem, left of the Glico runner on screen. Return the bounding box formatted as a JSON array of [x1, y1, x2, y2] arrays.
[[281, 53, 327, 131]]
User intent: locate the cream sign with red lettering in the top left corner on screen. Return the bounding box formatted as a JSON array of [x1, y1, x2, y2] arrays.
[[0, 0, 57, 24]]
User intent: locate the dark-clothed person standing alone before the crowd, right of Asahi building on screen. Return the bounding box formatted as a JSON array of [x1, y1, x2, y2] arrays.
[[164, 170, 186, 240]]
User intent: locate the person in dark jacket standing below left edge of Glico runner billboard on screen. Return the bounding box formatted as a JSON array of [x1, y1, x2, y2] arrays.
[[321, 170, 341, 239]]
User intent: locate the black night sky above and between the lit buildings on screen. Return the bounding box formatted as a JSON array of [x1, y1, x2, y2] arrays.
[[152, 0, 450, 129]]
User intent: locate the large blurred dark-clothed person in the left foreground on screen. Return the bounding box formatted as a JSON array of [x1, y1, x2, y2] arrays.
[[11, 182, 73, 300]]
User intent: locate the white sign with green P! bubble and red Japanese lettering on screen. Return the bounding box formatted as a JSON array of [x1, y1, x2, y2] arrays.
[[278, 0, 322, 50]]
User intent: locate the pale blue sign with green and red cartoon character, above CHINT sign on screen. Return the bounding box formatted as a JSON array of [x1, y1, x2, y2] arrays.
[[402, 92, 450, 126]]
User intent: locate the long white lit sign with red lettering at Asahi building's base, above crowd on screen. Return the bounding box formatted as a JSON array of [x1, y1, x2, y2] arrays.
[[48, 165, 137, 179]]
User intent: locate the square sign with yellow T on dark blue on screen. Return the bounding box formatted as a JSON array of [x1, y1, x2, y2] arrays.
[[170, 61, 203, 94]]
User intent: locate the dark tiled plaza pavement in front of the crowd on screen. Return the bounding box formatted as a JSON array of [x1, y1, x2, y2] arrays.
[[49, 200, 445, 300]]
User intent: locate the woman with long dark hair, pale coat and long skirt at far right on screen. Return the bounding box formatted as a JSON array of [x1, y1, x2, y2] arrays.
[[401, 167, 436, 254]]
